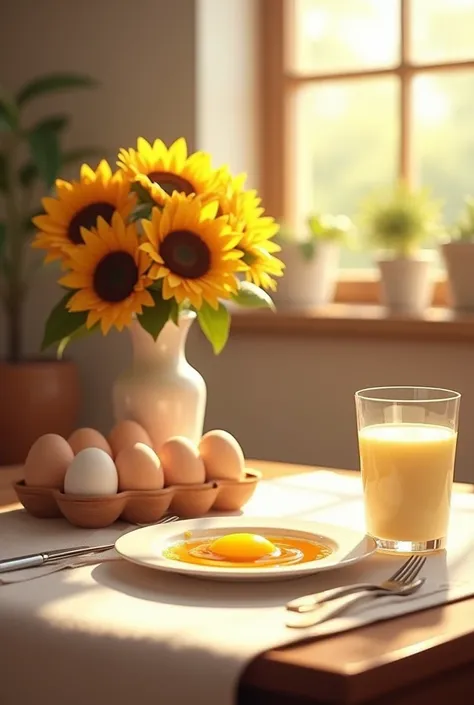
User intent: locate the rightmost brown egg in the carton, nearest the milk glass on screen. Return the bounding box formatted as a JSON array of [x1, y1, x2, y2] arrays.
[[199, 431, 245, 480]]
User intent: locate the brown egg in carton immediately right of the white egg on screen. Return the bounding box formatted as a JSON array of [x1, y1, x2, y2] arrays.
[[115, 443, 165, 492]]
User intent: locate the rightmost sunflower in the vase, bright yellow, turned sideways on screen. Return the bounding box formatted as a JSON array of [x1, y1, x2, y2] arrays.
[[219, 186, 285, 291]]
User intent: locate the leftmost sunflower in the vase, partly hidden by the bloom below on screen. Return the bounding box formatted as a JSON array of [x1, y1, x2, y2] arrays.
[[32, 160, 135, 262]]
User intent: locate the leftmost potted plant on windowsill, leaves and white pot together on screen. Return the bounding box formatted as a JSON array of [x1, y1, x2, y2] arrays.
[[275, 213, 355, 307]]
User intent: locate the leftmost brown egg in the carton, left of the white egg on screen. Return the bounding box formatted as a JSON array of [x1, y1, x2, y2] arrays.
[[23, 433, 74, 490]]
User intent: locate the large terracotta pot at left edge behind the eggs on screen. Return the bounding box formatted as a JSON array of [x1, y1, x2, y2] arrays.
[[0, 360, 80, 465]]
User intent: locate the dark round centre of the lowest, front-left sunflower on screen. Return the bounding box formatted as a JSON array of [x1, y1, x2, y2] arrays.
[[94, 252, 138, 303]]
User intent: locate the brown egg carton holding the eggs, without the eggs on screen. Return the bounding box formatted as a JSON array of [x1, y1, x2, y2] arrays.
[[14, 468, 262, 529]]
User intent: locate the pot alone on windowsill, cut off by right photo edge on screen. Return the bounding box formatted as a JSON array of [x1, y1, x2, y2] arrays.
[[441, 242, 474, 310]]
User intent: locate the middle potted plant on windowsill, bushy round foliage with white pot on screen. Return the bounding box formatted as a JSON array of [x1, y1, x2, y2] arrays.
[[361, 182, 440, 314]]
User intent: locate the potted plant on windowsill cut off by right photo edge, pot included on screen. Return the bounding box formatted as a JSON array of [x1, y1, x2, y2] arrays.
[[441, 196, 474, 310]]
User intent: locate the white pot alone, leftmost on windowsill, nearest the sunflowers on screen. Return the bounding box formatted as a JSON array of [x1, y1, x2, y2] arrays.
[[272, 242, 340, 307]]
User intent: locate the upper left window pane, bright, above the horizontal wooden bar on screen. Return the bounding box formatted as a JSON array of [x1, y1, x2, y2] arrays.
[[292, 0, 400, 73]]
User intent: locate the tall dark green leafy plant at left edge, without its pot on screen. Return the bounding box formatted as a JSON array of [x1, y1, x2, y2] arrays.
[[0, 73, 100, 363]]
